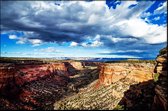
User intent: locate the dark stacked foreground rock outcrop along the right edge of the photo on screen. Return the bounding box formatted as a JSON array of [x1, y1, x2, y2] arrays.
[[153, 47, 168, 110]]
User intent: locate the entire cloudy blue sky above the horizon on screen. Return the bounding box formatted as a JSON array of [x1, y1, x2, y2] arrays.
[[0, 0, 167, 58]]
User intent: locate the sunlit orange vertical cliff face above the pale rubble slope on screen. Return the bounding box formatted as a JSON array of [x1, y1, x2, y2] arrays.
[[99, 63, 154, 85]]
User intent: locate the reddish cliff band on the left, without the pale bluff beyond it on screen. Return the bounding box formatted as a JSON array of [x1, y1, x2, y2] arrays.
[[0, 63, 68, 90]]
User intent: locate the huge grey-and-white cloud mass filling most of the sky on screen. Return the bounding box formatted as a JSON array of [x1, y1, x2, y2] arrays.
[[1, 1, 167, 57]]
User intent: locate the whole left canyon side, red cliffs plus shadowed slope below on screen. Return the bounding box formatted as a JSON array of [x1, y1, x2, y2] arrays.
[[0, 60, 98, 110]]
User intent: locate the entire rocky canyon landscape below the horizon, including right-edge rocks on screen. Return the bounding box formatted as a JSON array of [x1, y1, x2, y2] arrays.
[[0, 48, 167, 110]]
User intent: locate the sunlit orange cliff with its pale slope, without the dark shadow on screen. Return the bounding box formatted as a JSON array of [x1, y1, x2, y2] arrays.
[[54, 63, 154, 110]]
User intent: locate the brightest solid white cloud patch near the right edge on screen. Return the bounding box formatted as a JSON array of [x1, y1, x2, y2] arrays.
[[113, 18, 167, 44]]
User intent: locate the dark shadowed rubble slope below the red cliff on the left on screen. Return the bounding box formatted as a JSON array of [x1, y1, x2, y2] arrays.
[[0, 63, 98, 110]]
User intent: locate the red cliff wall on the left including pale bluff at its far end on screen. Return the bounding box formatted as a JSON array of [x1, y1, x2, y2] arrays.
[[0, 61, 84, 90]]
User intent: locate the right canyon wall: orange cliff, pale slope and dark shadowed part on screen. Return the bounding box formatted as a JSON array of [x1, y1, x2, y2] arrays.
[[54, 63, 154, 110]]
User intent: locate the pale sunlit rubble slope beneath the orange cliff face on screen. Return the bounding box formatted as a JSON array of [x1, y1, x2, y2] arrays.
[[54, 79, 137, 110]]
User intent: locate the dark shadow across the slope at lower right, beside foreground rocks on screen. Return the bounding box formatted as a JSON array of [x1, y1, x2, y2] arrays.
[[115, 80, 156, 111]]
